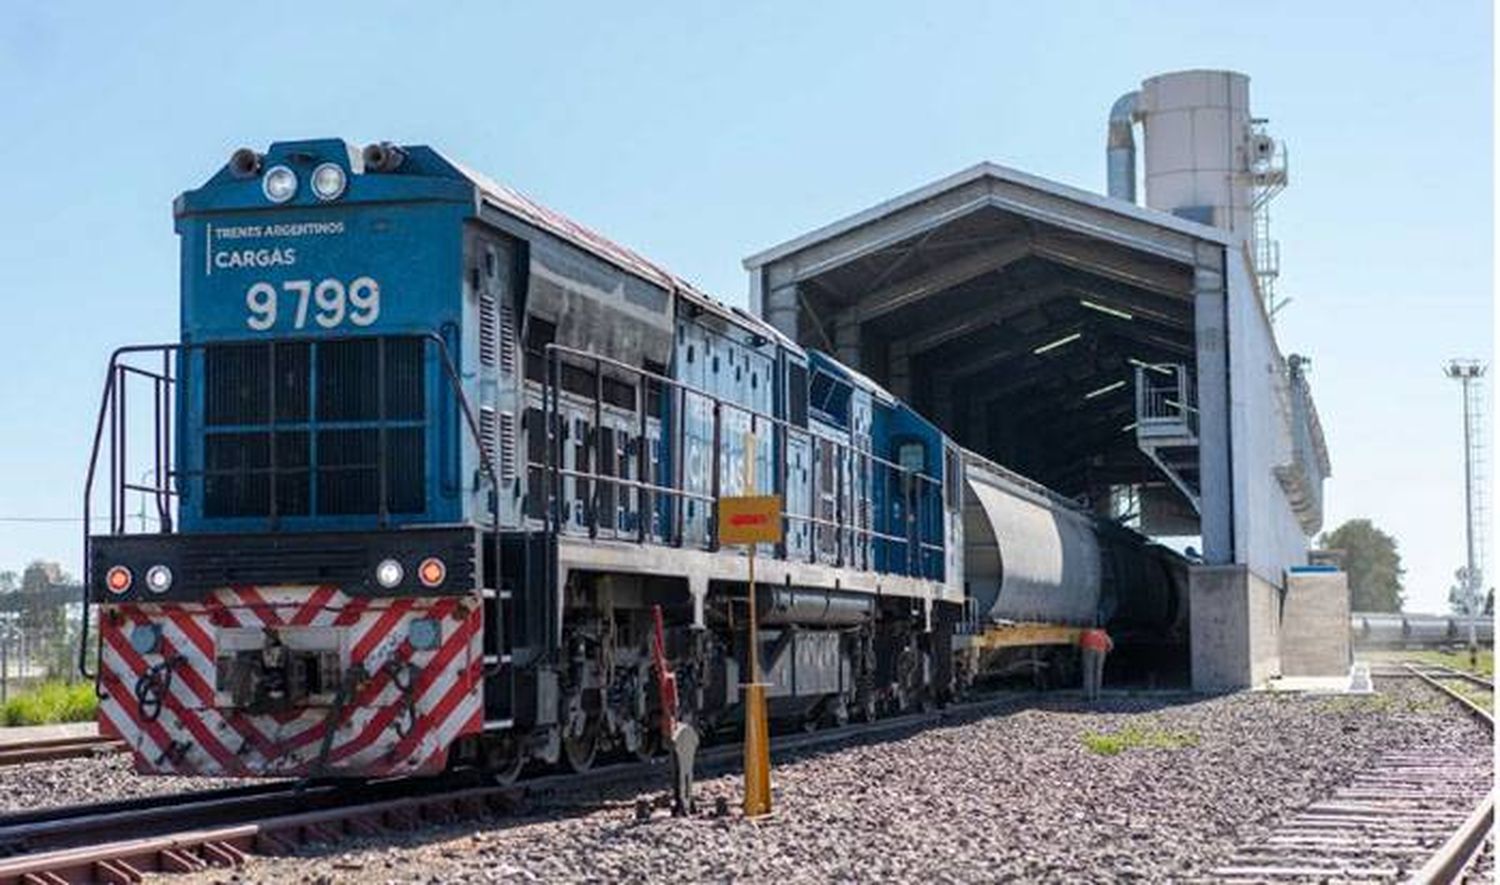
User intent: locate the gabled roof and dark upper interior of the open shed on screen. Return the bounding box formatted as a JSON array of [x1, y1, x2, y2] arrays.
[[744, 162, 1239, 504]]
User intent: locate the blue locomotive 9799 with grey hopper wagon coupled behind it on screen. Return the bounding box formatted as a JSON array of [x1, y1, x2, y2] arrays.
[[86, 140, 1184, 776]]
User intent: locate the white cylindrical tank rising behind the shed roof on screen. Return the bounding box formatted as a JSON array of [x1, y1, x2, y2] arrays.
[[1137, 71, 1253, 239]]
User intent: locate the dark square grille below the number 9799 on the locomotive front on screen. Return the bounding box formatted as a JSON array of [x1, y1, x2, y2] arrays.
[[203, 336, 428, 518]]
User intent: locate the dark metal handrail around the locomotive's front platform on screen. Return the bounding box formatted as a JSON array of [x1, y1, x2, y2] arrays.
[[78, 332, 501, 680]]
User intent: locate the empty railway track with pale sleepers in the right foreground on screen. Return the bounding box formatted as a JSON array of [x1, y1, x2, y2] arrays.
[[1214, 665, 1494, 884]]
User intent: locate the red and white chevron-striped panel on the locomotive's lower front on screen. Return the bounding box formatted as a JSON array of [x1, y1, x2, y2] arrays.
[[99, 585, 485, 777]]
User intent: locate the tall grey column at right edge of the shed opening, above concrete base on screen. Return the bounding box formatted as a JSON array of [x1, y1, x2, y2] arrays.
[[1193, 243, 1235, 566]]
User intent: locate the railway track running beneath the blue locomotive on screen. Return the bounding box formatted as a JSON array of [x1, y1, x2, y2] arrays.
[[0, 695, 1031, 885]]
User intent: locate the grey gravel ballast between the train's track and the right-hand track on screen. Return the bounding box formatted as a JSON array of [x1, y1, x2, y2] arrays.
[[43, 681, 1491, 885]]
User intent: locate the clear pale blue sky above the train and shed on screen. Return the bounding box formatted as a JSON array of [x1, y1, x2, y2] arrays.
[[0, 0, 1493, 608]]
